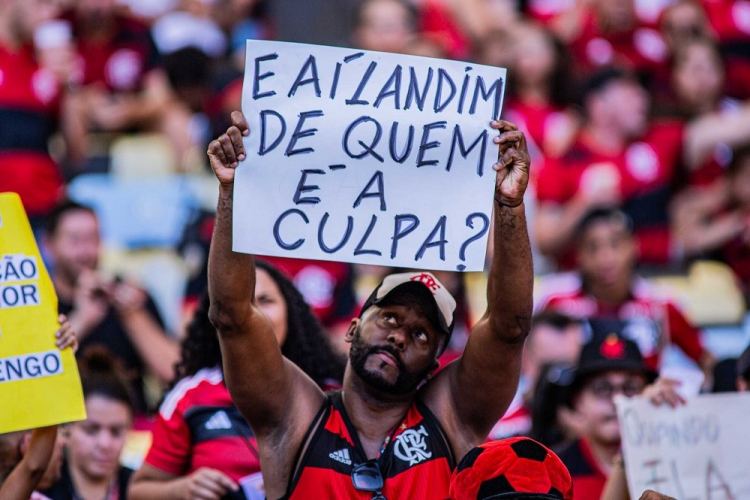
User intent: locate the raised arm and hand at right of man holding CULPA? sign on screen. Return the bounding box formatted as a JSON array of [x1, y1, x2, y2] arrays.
[[428, 121, 534, 446]]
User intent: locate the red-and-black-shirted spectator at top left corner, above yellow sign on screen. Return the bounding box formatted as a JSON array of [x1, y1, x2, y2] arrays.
[[0, 0, 73, 221]]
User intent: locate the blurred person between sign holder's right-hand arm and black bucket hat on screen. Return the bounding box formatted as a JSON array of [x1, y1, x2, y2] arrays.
[[490, 311, 583, 439]]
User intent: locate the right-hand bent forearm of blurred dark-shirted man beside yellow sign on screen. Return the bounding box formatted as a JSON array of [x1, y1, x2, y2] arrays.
[[123, 310, 180, 382]]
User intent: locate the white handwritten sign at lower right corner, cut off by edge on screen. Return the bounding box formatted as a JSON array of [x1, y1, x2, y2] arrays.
[[616, 394, 750, 500]]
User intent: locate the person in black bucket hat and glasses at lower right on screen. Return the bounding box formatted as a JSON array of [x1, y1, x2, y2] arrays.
[[558, 332, 684, 500]]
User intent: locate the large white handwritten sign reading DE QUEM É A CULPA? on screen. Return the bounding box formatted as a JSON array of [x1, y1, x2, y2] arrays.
[[233, 41, 506, 271]]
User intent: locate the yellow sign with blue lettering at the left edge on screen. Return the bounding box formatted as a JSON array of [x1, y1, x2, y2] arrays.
[[0, 193, 86, 433]]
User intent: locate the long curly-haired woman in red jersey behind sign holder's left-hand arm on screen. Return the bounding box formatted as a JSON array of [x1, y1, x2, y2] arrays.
[[129, 261, 344, 500]]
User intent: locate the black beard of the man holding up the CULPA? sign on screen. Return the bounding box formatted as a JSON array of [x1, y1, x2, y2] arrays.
[[349, 327, 432, 395]]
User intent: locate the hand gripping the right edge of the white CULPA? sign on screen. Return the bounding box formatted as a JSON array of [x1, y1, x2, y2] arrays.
[[490, 120, 531, 207]]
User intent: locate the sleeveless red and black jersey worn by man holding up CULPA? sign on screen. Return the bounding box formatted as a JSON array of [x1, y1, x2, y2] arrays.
[[283, 391, 455, 500]]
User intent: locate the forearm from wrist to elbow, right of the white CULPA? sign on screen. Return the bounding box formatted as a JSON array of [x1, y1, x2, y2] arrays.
[[487, 202, 534, 343]]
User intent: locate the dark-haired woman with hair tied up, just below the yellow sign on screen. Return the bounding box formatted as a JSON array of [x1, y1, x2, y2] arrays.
[[42, 347, 133, 500]]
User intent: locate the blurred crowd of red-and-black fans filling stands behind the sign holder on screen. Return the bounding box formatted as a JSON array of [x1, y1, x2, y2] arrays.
[[0, 0, 750, 500]]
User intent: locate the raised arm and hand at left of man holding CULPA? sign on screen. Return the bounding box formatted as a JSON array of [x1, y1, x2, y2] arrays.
[[208, 111, 324, 438]]
